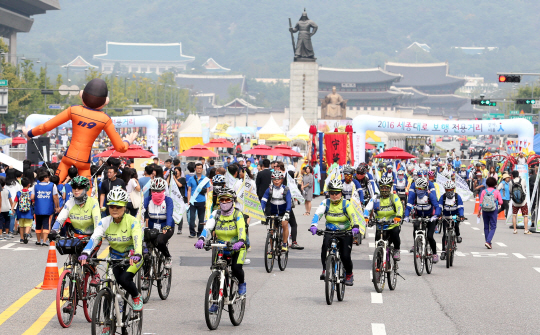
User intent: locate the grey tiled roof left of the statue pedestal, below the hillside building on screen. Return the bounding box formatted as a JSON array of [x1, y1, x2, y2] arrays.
[[176, 74, 246, 100]]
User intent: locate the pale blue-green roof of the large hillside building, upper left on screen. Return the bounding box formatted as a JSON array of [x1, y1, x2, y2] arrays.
[[94, 42, 195, 63]]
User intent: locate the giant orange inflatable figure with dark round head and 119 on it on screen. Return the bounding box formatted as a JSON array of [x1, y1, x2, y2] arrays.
[[23, 78, 137, 183]]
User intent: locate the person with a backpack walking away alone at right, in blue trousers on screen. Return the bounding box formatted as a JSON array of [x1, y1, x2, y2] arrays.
[[478, 176, 504, 249]]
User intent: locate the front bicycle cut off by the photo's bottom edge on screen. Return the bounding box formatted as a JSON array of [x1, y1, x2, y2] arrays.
[[88, 257, 143, 335]]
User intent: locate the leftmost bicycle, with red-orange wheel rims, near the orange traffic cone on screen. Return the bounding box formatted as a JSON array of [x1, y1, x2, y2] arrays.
[[56, 236, 97, 328]]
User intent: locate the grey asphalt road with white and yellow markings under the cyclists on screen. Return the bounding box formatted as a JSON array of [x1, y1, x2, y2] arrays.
[[0, 198, 540, 335]]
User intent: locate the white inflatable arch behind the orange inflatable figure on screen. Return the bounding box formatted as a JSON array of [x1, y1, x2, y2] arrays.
[[25, 114, 159, 155]]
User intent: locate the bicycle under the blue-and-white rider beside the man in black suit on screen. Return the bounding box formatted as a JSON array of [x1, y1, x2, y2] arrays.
[[264, 215, 289, 273]]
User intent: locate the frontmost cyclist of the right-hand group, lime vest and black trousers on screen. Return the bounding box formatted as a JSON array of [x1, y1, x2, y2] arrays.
[[309, 179, 360, 286]]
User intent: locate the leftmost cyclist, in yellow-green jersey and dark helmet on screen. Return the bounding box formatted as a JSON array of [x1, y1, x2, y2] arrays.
[[49, 176, 101, 285]]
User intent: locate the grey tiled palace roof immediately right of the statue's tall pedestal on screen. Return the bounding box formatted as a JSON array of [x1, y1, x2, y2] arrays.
[[319, 67, 402, 84]]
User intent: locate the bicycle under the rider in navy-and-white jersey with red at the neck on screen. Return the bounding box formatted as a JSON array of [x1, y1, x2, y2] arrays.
[[137, 228, 172, 304]]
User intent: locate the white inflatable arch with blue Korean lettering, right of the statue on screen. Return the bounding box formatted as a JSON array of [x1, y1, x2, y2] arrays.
[[353, 115, 534, 163]]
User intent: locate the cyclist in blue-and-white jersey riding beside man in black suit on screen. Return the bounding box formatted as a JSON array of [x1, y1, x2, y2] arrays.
[[261, 169, 292, 252]]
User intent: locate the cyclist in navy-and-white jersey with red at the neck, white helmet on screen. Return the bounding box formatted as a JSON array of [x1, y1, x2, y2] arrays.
[[144, 178, 174, 269]]
